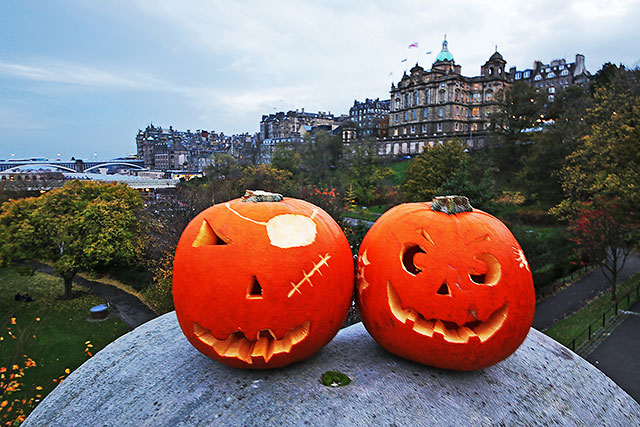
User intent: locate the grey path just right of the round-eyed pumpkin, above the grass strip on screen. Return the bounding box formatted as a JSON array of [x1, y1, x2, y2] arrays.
[[533, 254, 640, 331]]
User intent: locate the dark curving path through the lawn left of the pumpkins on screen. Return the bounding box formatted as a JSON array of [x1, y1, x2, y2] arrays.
[[33, 263, 157, 329]]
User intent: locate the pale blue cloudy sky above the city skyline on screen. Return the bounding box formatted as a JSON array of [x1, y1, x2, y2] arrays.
[[0, 0, 640, 160]]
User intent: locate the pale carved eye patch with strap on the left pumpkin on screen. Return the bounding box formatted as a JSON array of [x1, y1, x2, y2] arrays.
[[225, 203, 318, 249]]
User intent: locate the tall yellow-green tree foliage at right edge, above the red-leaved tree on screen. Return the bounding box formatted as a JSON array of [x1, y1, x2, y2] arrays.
[[554, 69, 640, 223]]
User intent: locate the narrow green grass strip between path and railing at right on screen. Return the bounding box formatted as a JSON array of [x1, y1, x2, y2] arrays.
[[543, 274, 640, 347]]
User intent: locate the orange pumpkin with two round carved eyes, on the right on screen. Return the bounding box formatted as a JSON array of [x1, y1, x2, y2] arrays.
[[357, 196, 535, 371]]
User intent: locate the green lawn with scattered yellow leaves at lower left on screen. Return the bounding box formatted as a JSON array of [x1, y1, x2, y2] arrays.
[[0, 268, 130, 425]]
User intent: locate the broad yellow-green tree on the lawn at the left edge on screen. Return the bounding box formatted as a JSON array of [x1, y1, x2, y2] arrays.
[[0, 181, 144, 298]]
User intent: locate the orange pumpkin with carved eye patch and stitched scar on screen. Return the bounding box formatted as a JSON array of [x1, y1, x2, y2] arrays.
[[173, 191, 353, 369]]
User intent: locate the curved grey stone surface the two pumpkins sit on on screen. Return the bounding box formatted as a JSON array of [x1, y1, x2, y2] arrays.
[[23, 313, 640, 427]]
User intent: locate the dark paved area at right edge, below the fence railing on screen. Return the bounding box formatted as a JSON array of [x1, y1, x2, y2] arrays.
[[587, 302, 640, 402]]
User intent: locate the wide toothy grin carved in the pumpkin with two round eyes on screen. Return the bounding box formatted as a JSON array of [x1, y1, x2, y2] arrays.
[[387, 282, 509, 343]]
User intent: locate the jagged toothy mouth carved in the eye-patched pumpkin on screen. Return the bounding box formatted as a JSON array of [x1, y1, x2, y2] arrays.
[[193, 320, 311, 364]]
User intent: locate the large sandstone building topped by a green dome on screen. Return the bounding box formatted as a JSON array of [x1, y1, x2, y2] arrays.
[[380, 35, 513, 155]]
